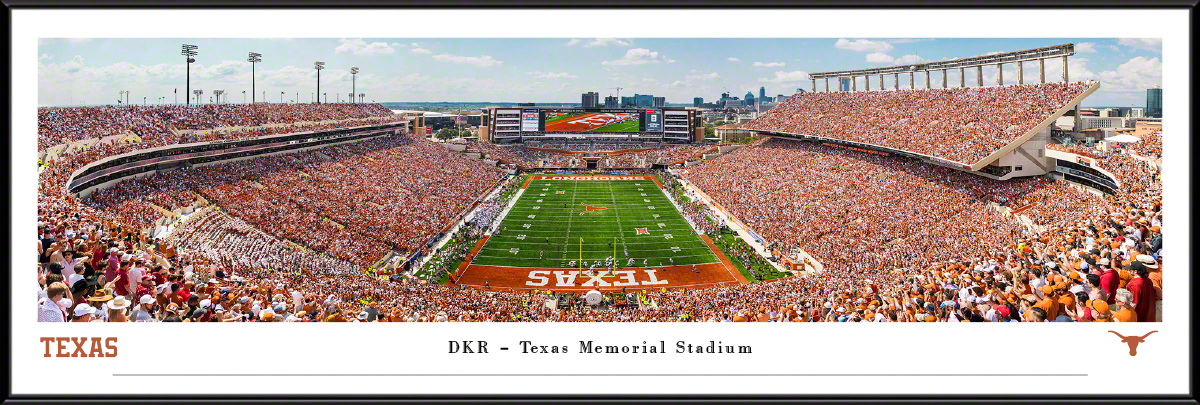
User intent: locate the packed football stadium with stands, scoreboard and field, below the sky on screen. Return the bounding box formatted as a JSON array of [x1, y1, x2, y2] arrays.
[[37, 44, 1164, 322]]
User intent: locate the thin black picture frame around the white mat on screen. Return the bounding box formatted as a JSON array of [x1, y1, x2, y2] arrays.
[[0, 0, 1200, 405]]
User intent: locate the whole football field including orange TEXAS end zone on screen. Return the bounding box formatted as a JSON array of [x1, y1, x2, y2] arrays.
[[458, 175, 744, 290]]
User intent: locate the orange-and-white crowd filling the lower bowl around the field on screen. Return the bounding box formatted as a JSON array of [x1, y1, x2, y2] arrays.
[[37, 99, 1163, 322]]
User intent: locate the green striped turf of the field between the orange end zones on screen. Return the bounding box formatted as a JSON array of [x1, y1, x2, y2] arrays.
[[474, 180, 719, 268]]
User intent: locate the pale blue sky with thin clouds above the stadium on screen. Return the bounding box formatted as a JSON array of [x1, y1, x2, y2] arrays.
[[38, 38, 1163, 107]]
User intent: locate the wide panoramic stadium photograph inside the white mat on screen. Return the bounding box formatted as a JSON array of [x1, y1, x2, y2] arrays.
[[37, 37, 1161, 323]]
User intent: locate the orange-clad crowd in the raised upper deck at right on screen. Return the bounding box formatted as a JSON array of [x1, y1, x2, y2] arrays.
[[743, 81, 1092, 164]]
